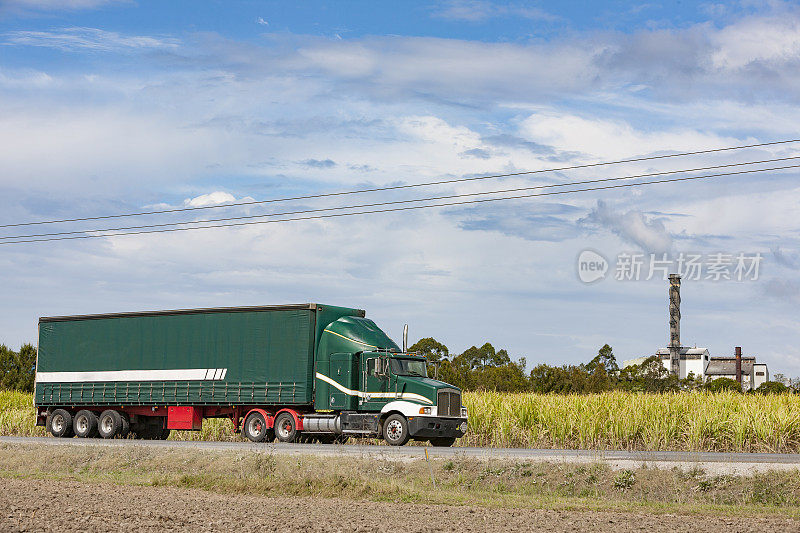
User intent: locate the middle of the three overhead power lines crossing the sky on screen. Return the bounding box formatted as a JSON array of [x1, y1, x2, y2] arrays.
[[0, 156, 800, 241]]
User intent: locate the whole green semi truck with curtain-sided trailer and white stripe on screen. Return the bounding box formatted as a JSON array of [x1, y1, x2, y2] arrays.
[[35, 304, 467, 446]]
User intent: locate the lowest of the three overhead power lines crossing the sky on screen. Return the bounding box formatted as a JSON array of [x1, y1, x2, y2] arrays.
[[0, 165, 800, 246]]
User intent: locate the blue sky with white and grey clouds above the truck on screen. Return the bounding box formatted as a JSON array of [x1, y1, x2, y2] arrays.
[[0, 0, 800, 375]]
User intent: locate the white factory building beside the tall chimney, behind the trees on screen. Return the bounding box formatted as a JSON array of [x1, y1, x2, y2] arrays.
[[622, 346, 769, 391]]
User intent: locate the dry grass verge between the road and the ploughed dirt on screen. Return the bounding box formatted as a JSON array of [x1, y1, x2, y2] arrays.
[[0, 444, 800, 518]]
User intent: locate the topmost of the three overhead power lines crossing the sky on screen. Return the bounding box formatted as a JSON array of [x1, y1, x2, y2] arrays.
[[6, 139, 800, 228]]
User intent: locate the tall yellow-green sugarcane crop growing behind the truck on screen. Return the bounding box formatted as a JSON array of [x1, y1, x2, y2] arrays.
[[0, 391, 800, 452]]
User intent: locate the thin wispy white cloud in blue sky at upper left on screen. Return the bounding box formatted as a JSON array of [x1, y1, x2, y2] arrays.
[[3, 28, 179, 52]]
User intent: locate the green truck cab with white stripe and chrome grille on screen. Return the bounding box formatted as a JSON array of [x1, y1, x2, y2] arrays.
[[310, 316, 467, 446]]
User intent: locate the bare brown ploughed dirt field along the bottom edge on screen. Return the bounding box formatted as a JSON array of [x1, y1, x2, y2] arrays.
[[0, 479, 800, 533]]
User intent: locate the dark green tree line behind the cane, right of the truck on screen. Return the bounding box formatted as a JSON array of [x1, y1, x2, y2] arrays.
[[409, 337, 800, 394]]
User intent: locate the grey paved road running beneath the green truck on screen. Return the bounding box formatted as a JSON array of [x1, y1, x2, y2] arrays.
[[0, 437, 800, 474]]
